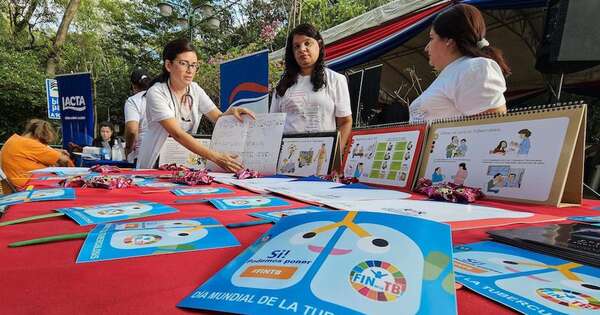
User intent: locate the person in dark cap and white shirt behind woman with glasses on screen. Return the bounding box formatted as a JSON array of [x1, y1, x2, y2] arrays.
[[123, 68, 152, 163]]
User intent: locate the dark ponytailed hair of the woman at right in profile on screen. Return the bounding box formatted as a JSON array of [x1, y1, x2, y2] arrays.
[[433, 4, 511, 76]]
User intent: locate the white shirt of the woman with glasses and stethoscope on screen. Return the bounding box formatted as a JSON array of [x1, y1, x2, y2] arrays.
[[137, 82, 217, 168]]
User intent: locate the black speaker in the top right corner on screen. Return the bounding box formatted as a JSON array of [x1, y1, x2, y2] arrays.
[[535, 0, 600, 73]]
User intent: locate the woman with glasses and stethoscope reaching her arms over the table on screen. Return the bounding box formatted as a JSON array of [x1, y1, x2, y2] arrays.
[[137, 39, 254, 172]]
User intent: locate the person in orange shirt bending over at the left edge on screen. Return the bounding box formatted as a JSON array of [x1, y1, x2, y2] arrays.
[[0, 119, 74, 189]]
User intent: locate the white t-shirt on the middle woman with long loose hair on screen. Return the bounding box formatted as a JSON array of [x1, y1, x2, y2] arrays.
[[270, 68, 352, 133]]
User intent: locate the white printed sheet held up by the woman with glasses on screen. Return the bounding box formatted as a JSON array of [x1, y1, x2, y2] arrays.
[[208, 113, 285, 175]]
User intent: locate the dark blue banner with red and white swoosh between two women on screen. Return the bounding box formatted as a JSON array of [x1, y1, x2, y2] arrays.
[[220, 50, 269, 113]]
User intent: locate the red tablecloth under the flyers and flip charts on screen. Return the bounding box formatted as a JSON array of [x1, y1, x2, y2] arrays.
[[0, 174, 600, 314]]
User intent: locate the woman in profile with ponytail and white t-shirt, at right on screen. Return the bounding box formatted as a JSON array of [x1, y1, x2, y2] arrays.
[[409, 4, 510, 121]]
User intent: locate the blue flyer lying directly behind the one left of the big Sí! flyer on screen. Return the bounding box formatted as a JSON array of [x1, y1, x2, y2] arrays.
[[56, 201, 177, 225]]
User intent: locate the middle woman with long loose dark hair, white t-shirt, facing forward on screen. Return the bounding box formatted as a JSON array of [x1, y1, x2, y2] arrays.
[[271, 24, 352, 152]]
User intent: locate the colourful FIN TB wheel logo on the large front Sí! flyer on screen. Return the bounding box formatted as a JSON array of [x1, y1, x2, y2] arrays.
[[350, 260, 406, 302]]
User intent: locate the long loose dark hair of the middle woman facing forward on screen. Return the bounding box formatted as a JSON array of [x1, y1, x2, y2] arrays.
[[275, 23, 327, 97]]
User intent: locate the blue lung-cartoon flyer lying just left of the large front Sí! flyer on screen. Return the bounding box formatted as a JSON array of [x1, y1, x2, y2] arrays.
[[77, 218, 240, 263]]
